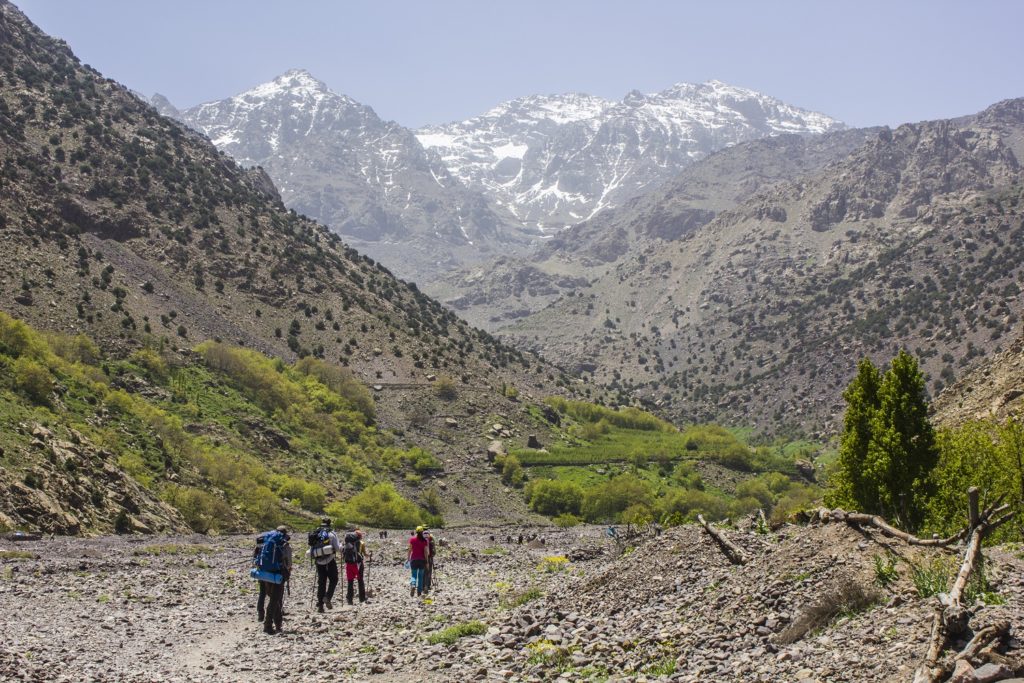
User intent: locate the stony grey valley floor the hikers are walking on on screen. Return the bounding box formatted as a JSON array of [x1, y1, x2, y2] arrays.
[[0, 524, 1024, 683]]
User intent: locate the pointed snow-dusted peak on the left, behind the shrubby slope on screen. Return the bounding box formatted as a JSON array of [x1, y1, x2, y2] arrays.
[[169, 70, 526, 280]]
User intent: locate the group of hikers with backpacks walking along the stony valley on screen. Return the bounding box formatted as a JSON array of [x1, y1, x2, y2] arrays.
[[250, 517, 436, 634]]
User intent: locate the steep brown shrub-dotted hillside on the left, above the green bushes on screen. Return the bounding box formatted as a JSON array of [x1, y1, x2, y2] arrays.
[[0, 2, 585, 532]]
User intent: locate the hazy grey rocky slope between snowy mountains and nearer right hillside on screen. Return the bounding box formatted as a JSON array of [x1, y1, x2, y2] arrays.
[[433, 129, 878, 332]]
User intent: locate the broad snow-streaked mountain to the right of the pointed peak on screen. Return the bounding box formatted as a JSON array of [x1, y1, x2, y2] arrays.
[[416, 81, 843, 230]]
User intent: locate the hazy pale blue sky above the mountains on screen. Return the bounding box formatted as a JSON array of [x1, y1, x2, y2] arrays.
[[14, 0, 1024, 126]]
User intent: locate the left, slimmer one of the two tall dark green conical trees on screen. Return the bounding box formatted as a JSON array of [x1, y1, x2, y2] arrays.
[[825, 358, 882, 510]]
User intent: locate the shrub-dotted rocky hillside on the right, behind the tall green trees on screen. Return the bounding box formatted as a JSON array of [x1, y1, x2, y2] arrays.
[[503, 100, 1024, 431]]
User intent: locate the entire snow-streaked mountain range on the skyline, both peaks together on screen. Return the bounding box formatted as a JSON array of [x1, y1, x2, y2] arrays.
[[159, 70, 842, 292]]
